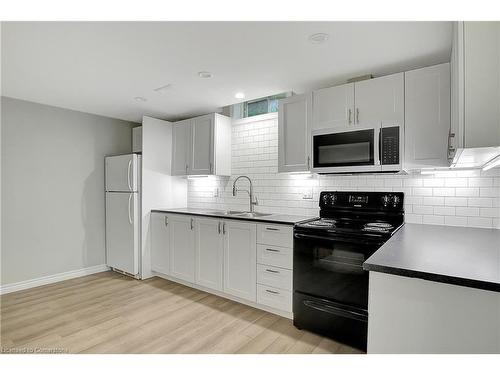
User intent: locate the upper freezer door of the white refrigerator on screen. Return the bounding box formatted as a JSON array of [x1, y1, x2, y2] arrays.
[[105, 154, 138, 192]]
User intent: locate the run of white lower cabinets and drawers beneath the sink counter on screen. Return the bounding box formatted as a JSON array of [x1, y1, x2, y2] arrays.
[[151, 212, 293, 317]]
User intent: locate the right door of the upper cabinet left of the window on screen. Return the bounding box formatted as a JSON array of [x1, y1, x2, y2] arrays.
[[188, 115, 214, 175]]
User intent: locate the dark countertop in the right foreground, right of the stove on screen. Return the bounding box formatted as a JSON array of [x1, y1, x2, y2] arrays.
[[363, 224, 500, 292]]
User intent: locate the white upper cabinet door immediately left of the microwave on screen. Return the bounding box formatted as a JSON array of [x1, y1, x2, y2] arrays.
[[278, 94, 311, 172]]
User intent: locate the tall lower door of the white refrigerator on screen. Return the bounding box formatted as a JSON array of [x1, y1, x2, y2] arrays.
[[106, 193, 139, 275]]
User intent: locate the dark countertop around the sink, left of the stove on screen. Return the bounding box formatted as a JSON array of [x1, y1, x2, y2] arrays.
[[151, 208, 314, 225]]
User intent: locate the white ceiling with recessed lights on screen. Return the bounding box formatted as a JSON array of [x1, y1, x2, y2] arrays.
[[2, 22, 452, 122]]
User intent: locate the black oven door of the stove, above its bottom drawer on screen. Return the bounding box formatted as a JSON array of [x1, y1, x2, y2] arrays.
[[293, 232, 380, 310]]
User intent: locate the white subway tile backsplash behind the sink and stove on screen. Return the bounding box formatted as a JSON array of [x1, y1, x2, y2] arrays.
[[188, 118, 500, 228]]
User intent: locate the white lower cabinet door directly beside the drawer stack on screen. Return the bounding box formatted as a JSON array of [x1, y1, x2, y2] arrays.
[[224, 221, 257, 302]]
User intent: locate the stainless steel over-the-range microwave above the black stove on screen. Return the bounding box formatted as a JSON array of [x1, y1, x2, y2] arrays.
[[312, 124, 403, 173]]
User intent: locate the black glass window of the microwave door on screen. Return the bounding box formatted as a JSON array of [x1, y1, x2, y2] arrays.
[[313, 129, 374, 167]]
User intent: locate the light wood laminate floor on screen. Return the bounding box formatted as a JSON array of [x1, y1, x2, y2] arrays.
[[1, 272, 360, 354]]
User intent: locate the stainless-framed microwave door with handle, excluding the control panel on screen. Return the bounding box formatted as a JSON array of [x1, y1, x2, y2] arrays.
[[312, 127, 381, 173]]
